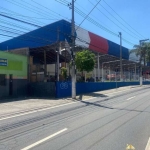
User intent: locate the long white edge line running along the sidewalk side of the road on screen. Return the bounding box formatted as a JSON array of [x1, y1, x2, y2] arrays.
[[0, 89, 137, 121]]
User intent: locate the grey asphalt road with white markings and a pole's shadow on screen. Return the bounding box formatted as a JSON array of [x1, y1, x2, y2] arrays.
[[0, 86, 150, 150]]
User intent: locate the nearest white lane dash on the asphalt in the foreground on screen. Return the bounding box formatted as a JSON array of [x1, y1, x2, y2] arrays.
[[21, 128, 68, 150]]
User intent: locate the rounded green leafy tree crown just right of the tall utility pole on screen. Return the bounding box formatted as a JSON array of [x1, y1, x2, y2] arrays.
[[75, 50, 95, 72]]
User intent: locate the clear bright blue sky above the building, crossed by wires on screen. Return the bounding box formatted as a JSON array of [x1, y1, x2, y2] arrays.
[[0, 0, 150, 49]]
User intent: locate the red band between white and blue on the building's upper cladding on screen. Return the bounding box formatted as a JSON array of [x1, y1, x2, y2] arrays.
[[89, 32, 109, 54]]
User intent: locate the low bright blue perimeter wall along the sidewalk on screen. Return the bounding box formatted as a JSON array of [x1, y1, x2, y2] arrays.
[[56, 82, 150, 98]]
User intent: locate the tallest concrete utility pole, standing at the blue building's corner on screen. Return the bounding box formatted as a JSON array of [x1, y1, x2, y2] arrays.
[[72, 0, 76, 99]]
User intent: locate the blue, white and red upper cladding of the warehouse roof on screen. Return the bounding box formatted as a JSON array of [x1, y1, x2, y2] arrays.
[[0, 20, 129, 60]]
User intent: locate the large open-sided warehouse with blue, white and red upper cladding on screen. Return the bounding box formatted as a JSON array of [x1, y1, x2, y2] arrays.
[[0, 20, 145, 96]]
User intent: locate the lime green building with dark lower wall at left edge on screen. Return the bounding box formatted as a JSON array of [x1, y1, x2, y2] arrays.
[[0, 51, 28, 98]]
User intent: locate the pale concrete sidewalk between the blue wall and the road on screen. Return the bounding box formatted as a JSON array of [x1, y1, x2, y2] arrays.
[[0, 86, 145, 117]]
